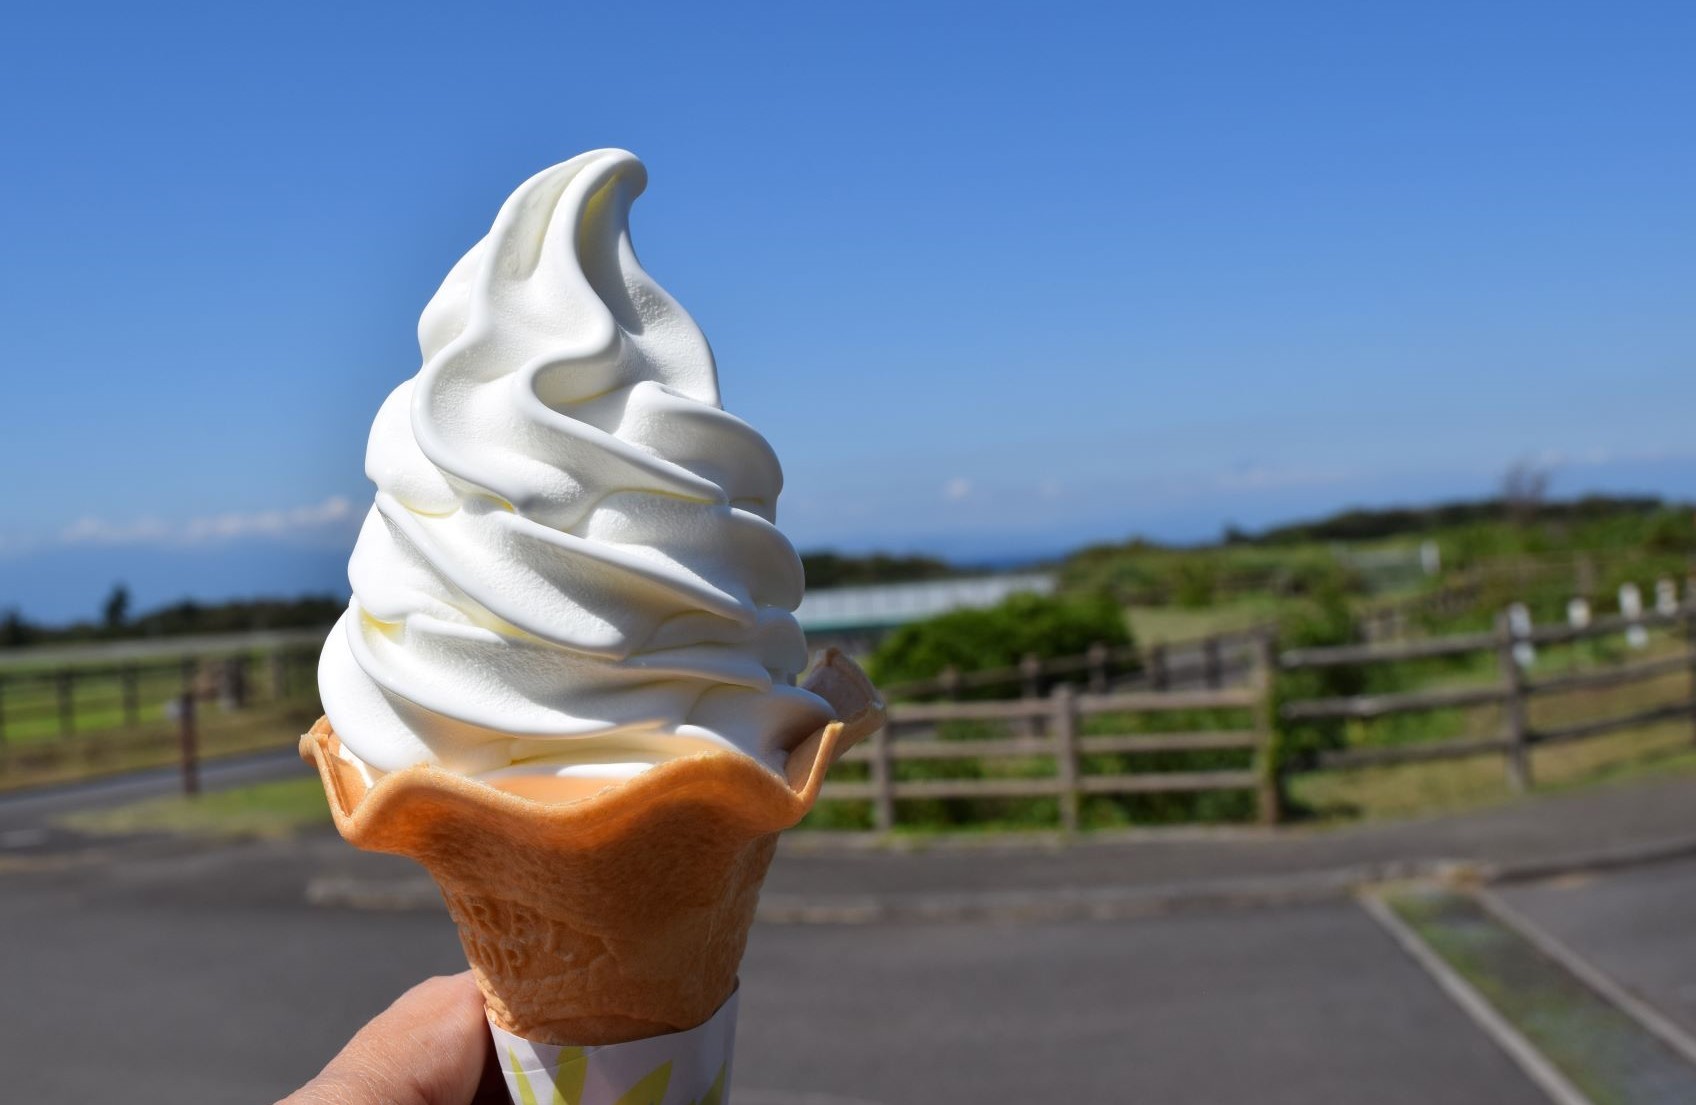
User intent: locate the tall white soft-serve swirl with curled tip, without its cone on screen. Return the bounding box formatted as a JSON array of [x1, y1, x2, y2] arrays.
[[319, 149, 831, 775]]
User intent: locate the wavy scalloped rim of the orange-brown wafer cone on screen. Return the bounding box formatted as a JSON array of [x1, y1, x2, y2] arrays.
[[300, 649, 884, 851]]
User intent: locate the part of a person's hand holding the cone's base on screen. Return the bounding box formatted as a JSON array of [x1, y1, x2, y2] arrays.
[[278, 971, 507, 1105]]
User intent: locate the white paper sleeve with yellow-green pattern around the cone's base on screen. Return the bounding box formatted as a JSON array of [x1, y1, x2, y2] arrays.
[[488, 993, 736, 1105]]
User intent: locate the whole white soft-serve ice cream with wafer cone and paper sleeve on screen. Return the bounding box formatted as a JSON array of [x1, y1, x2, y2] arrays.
[[300, 151, 884, 1057]]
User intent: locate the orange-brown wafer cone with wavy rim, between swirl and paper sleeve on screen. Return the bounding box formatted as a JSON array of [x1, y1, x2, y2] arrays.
[[300, 649, 884, 1046]]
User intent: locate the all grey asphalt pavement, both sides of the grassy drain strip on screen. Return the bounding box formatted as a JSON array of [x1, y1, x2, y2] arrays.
[[0, 772, 1696, 1105]]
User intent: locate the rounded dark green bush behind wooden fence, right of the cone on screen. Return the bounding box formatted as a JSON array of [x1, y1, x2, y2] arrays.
[[870, 593, 1131, 685]]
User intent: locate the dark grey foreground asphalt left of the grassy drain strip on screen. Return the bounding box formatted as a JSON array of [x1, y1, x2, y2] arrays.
[[0, 842, 1540, 1105]]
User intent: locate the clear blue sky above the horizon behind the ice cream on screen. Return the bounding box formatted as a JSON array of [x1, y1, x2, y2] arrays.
[[0, 2, 1696, 619]]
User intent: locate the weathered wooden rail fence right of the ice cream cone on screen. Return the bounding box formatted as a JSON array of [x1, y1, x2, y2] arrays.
[[823, 605, 1696, 830]]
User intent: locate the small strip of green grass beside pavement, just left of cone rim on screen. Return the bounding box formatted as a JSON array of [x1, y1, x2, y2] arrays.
[[58, 776, 329, 839]]
